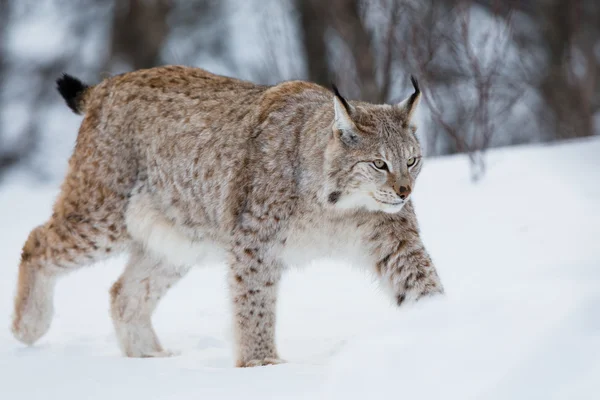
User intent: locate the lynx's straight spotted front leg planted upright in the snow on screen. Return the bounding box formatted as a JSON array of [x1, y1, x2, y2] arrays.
[[229, 248, 283, 367]]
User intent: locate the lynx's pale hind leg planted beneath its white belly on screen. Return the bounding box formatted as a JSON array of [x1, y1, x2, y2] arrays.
[[110, 245, 190, 357]]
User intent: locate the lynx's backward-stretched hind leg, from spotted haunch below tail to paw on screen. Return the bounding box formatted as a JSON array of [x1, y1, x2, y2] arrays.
[[12, 108, 137, 344]]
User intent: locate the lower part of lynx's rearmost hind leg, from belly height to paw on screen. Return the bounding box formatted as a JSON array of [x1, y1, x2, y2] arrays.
[[12, 191, 126, 345]]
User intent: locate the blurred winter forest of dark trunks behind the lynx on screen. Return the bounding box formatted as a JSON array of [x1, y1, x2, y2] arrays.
[[0, 0, 600, 182]]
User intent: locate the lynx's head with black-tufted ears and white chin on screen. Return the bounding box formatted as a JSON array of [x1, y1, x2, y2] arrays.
[[324, 77, 422, 213]]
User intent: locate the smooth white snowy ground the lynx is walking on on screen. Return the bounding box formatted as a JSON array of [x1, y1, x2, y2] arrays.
[[0, 139, 600, 400]]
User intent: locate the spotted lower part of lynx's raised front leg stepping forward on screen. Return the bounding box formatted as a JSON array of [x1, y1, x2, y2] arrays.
[[375, 236, 444, 306]]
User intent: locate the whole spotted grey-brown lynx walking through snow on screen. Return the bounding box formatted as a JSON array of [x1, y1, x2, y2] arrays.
[[12, 66, 443, 367]]
